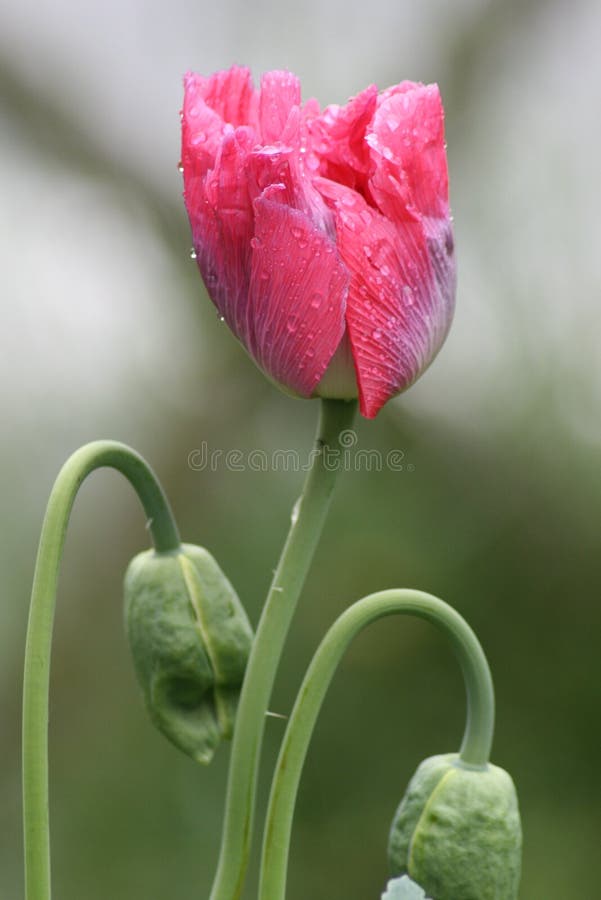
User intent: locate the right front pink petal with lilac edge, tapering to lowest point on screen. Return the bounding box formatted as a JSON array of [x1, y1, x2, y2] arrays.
[[318, 179, 455, 418]]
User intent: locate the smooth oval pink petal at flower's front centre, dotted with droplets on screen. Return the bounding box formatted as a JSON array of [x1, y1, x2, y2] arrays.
[[248, 185, 348, 397]]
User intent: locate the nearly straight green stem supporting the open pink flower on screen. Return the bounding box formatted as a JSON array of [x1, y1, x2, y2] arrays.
[[211, 400, 356, 900]]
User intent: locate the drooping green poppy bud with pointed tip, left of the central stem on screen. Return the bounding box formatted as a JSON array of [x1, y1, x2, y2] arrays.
[[125, 544, 252, 763]]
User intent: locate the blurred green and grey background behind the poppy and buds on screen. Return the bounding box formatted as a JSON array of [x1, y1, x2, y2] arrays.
[[0, 0, 601, 900]]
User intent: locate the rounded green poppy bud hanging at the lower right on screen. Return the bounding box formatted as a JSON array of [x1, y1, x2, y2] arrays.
[[388, 753, 522, 900]]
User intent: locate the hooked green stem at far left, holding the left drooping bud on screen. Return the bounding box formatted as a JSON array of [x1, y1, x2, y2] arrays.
[[23, 441, 180, 900]]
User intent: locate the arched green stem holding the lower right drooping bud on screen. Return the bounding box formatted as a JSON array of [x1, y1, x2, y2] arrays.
[[259, 590, 494, 900]]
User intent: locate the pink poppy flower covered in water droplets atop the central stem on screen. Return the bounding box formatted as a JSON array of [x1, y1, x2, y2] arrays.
[[182, 66, 455, 418]]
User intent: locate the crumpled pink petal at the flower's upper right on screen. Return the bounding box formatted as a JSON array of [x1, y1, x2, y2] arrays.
[[366, 82, 449, 220]]
